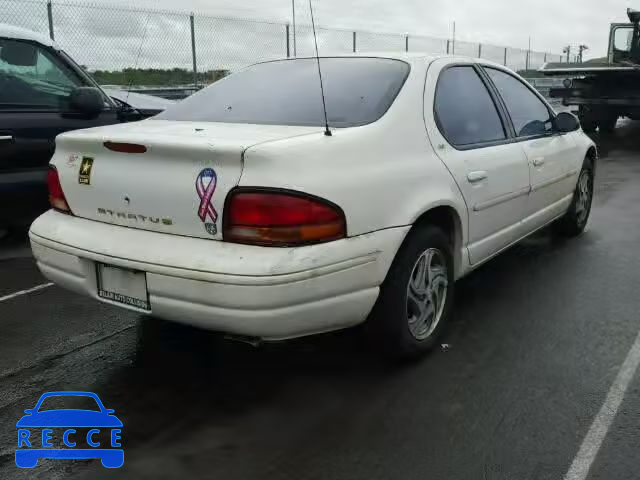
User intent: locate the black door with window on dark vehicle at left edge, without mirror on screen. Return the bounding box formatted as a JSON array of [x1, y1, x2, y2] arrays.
[[0, 38, 118, 223]]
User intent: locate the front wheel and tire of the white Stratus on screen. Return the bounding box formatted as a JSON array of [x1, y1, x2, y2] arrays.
[[554, 158, 594, 237]]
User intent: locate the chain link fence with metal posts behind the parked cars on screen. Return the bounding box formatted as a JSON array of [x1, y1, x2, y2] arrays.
[[0, 0, 563, 86]]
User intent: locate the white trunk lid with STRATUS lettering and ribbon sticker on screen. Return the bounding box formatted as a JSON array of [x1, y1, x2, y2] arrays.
[[52, 120, 322, 240]]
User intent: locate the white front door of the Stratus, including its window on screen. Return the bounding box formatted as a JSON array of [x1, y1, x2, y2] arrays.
[[485, 67, 581, 230]]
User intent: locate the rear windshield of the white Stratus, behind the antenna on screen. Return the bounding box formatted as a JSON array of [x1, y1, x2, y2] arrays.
[[155, 58, 409, 127]]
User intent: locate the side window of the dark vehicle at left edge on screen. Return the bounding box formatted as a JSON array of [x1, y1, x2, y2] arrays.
[[0, 39, 83, 110]]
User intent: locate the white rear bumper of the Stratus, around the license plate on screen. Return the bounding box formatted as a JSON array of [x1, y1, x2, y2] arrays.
[[30, 211, 408, 340]]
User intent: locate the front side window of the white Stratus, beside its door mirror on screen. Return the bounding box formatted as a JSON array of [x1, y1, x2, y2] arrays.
[[485, 68, 553, 137]]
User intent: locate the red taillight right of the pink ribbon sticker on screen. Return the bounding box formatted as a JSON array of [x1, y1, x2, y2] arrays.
[[223, 190, 346, 247]]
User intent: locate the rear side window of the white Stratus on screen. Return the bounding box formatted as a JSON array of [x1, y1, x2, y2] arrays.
[[435, 66, 506, 146]]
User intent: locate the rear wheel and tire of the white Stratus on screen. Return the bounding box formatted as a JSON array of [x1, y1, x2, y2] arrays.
[[365, 225, 454, 360]]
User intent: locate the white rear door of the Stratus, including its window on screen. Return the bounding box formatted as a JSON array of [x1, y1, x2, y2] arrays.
[[425, 59, 530, 264]]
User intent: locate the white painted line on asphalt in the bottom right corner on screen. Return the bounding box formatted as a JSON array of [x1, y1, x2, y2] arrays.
[[564, 334, 640, 480]]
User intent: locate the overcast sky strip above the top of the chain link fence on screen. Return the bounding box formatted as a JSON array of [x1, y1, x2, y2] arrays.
[[101, 0, 640, 57]]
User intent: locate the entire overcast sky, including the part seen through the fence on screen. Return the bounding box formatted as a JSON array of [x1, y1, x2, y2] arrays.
[[5, 0, 640, 71]]
